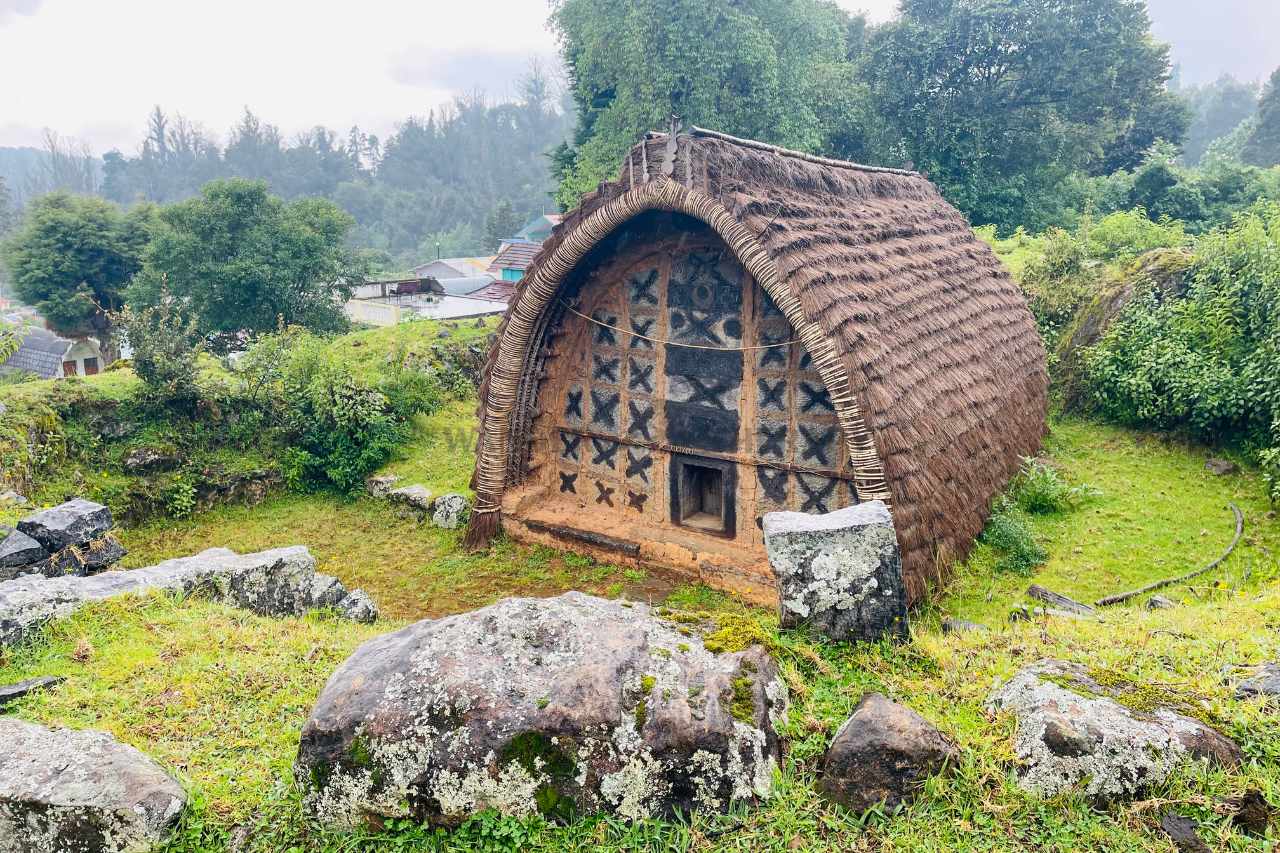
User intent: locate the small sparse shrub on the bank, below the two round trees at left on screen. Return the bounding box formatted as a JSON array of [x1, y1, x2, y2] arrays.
[[114, 288, 204, 401]]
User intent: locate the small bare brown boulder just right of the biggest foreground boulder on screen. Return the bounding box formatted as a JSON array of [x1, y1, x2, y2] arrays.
[[818, 693, 960, 812]]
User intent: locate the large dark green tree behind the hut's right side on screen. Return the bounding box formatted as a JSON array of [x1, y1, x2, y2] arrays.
[[865, 0, 1169, 228]]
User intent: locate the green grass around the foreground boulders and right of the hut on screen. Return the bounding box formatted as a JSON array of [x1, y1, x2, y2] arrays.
[[0, 414, 1280, 853]]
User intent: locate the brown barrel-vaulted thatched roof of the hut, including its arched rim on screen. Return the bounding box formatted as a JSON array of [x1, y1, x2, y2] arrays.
[[468, 129, 1047, 601]]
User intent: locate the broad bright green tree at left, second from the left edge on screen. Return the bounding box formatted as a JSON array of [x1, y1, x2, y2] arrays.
[[128, 178, 364, 338]]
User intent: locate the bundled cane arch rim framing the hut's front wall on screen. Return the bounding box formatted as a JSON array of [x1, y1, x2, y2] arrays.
[[474, 178, 891, 516]]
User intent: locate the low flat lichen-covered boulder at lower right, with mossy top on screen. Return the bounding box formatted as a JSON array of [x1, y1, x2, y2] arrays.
[[988, 660, 1242, 799]]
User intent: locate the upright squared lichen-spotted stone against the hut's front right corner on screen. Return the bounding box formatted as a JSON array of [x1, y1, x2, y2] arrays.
[[764, 501, 908, 640]]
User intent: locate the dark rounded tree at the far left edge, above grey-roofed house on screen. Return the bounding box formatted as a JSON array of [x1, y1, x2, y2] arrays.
[[4, 192, 154, 346]]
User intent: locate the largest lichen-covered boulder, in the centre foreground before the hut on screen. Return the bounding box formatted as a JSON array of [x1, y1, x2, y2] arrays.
[[294, 592, 786, 826]]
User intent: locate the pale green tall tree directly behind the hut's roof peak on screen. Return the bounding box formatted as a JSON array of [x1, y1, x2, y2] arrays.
[[552, 0, 850, 207]]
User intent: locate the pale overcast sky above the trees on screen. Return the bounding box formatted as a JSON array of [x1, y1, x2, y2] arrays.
[[0, 0, 1280, 152]]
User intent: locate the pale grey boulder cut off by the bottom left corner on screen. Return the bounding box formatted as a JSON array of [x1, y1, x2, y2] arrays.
[[0, 717, 187, 853]]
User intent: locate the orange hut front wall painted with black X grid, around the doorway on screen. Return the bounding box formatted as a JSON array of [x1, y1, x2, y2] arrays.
[[539, 233, 855, 540]]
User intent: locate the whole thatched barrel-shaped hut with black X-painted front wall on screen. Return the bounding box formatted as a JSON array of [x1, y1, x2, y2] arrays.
[[467, 128, 1047, 601]]
